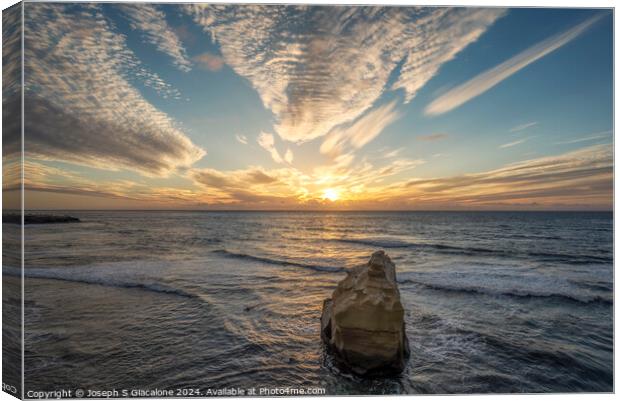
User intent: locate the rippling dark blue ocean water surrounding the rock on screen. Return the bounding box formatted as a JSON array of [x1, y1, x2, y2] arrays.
[[3, 211, 613, 395]]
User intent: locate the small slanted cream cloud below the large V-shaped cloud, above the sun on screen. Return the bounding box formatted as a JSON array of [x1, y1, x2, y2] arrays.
[[321, 102, 399, 155]]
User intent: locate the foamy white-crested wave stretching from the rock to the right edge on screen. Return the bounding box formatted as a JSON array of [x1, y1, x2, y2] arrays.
[[398, 279, 613, 305]]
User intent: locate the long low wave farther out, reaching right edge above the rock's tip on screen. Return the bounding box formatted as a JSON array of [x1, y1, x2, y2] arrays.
[[329, 238, 613, 265]]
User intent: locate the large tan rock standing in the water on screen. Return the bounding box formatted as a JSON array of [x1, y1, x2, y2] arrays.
[[321, 251, 409, 376]]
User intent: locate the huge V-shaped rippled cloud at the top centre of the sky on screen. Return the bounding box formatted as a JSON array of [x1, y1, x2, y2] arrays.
[[185, 4, 505, 142]]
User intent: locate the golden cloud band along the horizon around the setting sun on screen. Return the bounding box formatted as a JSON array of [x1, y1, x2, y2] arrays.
[[25, 145, 613, 210]]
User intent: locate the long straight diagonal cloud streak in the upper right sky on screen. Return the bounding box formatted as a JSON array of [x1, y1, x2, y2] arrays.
[[424, 14, 603, 116]]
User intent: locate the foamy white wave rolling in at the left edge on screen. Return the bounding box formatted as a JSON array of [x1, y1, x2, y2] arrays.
[[2, 266, 204, 301]]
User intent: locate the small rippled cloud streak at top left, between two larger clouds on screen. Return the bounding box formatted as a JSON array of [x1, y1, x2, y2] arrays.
[[116, 3, 191, 72]]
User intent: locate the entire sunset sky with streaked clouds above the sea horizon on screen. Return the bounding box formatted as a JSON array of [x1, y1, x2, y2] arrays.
[[4, 3, 613, 210]]
